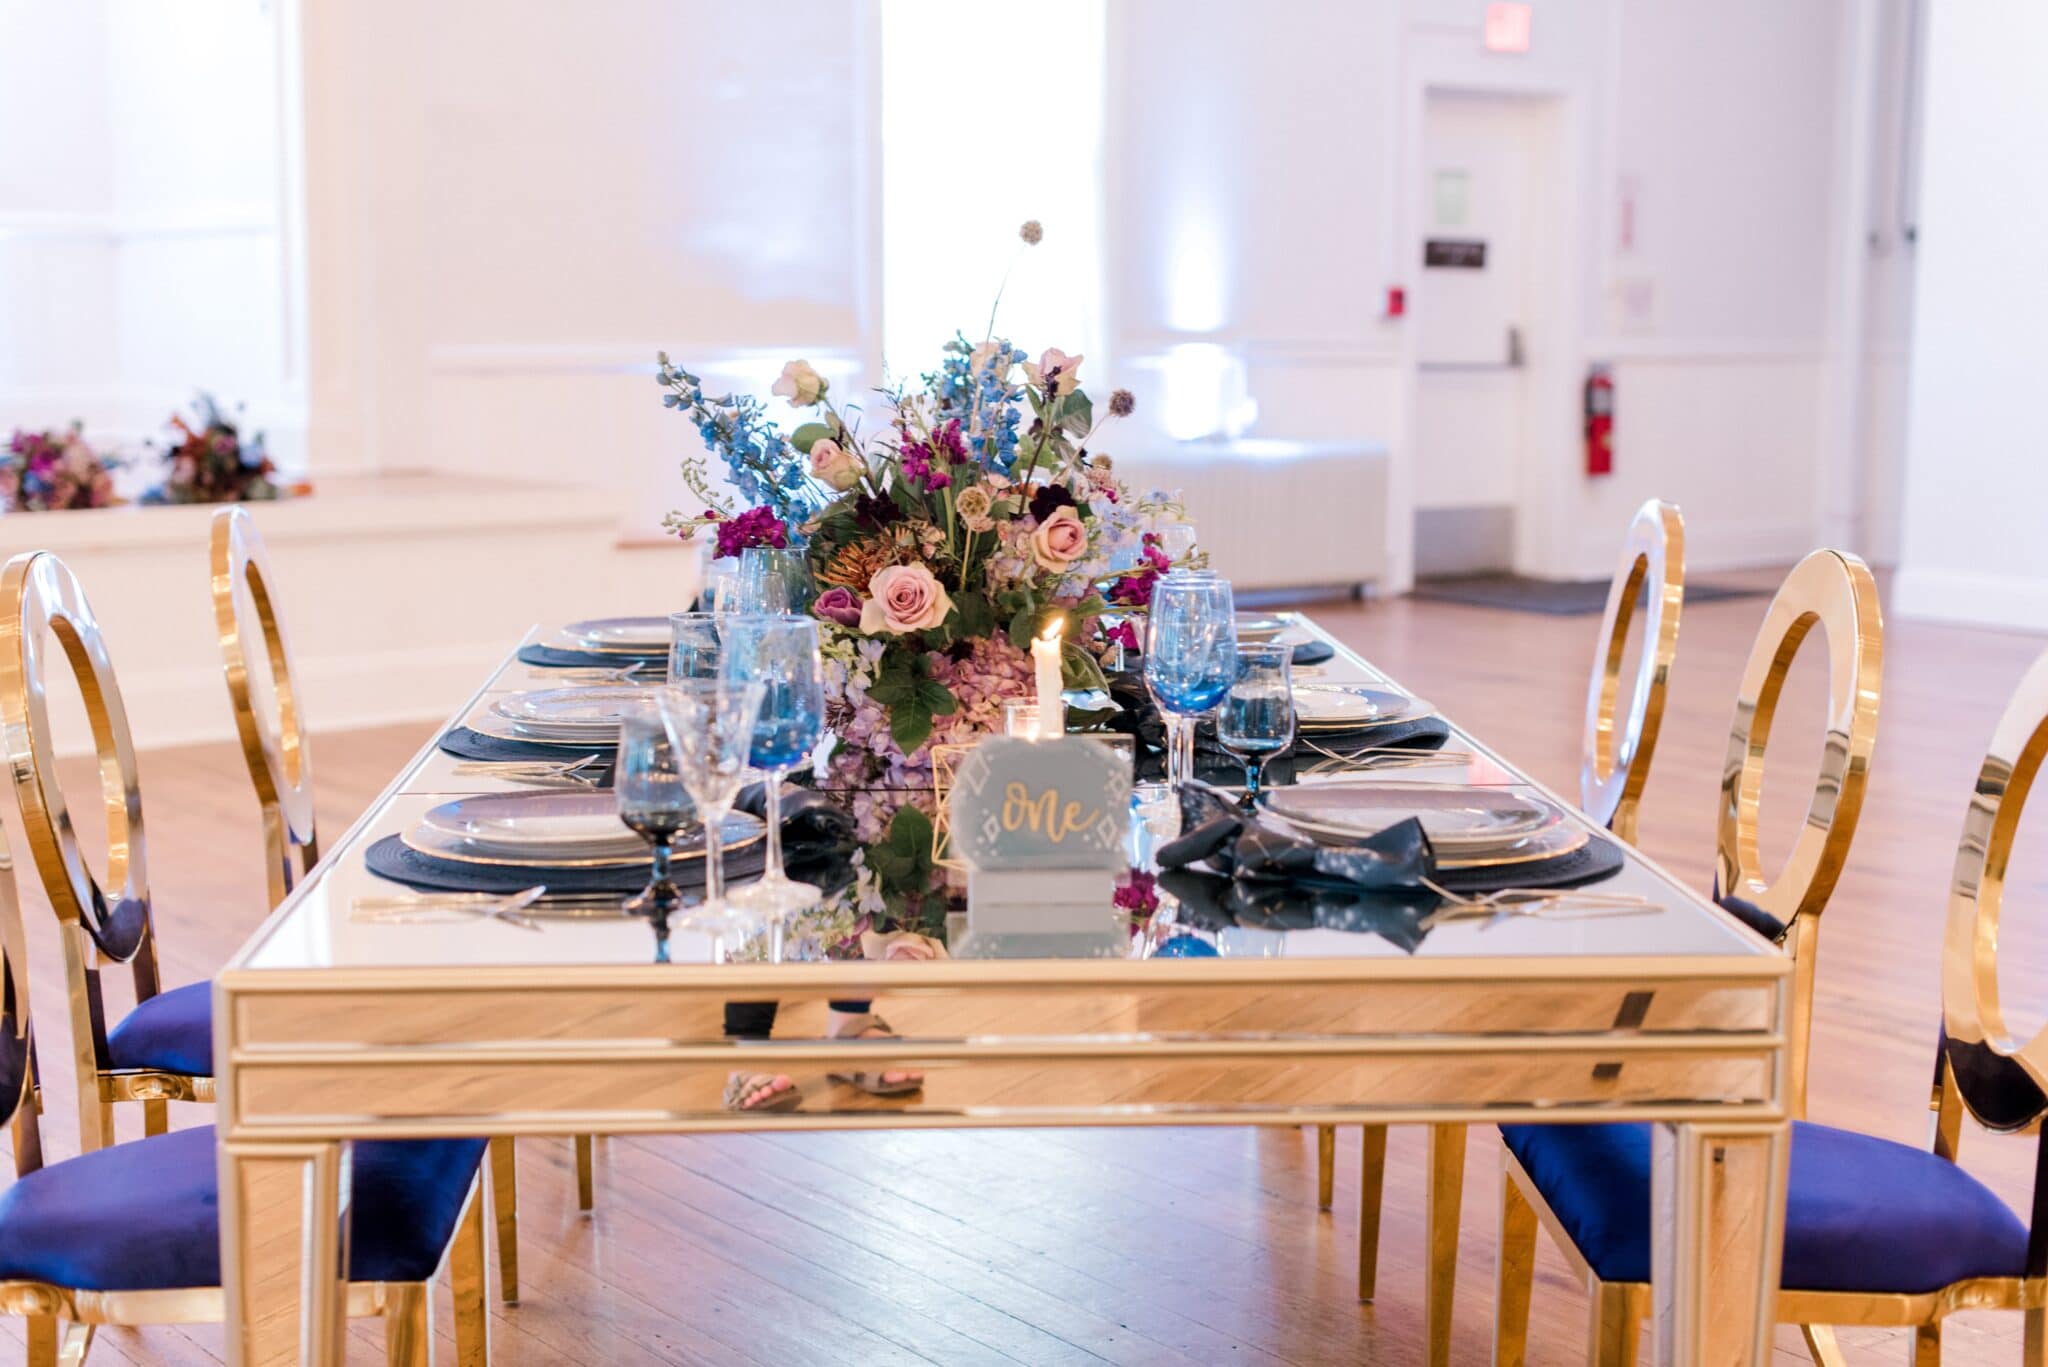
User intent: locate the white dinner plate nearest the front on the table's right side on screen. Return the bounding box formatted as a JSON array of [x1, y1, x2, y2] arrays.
[[1266, 783, 1563, 853]]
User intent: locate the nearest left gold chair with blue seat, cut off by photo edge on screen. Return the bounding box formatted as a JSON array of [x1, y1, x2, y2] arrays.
[[0, 795, 489, 1367]]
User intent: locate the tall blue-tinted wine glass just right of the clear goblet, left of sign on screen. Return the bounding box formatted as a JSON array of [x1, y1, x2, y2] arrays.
[[719, 613, 825, 912]]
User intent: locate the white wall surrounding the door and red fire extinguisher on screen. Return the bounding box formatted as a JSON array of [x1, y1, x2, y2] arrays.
[[1110, 0, 1849, 576]]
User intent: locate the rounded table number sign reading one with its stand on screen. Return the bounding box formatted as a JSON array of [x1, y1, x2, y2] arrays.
[[948, 736, 1130, 935]]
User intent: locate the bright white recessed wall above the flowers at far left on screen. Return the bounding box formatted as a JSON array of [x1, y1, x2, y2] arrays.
[[0, 0, 303, 465]]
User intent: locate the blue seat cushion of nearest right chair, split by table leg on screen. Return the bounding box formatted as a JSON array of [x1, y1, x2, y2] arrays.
[[1501, 1121, 2028, 1293]]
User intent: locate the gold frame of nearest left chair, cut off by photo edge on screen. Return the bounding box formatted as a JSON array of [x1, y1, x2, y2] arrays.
[[0, 811, 489, 1367]]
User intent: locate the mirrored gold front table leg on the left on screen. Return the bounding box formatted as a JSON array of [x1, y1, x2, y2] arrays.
[[219, 1142, 348, 1367]]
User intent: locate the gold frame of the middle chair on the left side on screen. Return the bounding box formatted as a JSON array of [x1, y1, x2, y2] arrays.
[[0, 551, 213, 1150]]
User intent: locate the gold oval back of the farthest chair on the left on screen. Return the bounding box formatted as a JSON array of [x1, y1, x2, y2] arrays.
[[213, 506, 319, 906]]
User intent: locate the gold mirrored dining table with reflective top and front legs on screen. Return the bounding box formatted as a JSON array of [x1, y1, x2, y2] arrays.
[[215, 619, 1790, 1367]]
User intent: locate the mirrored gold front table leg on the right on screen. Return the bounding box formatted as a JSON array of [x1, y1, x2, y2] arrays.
[[1651, 1121, 1792, 1367]]
